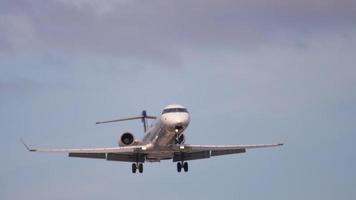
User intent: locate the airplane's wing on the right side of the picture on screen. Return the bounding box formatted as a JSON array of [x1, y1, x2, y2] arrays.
[[173, 144, 283, 162]]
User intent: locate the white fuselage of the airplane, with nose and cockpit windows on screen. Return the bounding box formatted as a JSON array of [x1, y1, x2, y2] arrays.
[[142, 105, 190, 161]]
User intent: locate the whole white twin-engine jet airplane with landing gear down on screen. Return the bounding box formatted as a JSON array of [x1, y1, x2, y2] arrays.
[[21, 104, 283, 173]]
